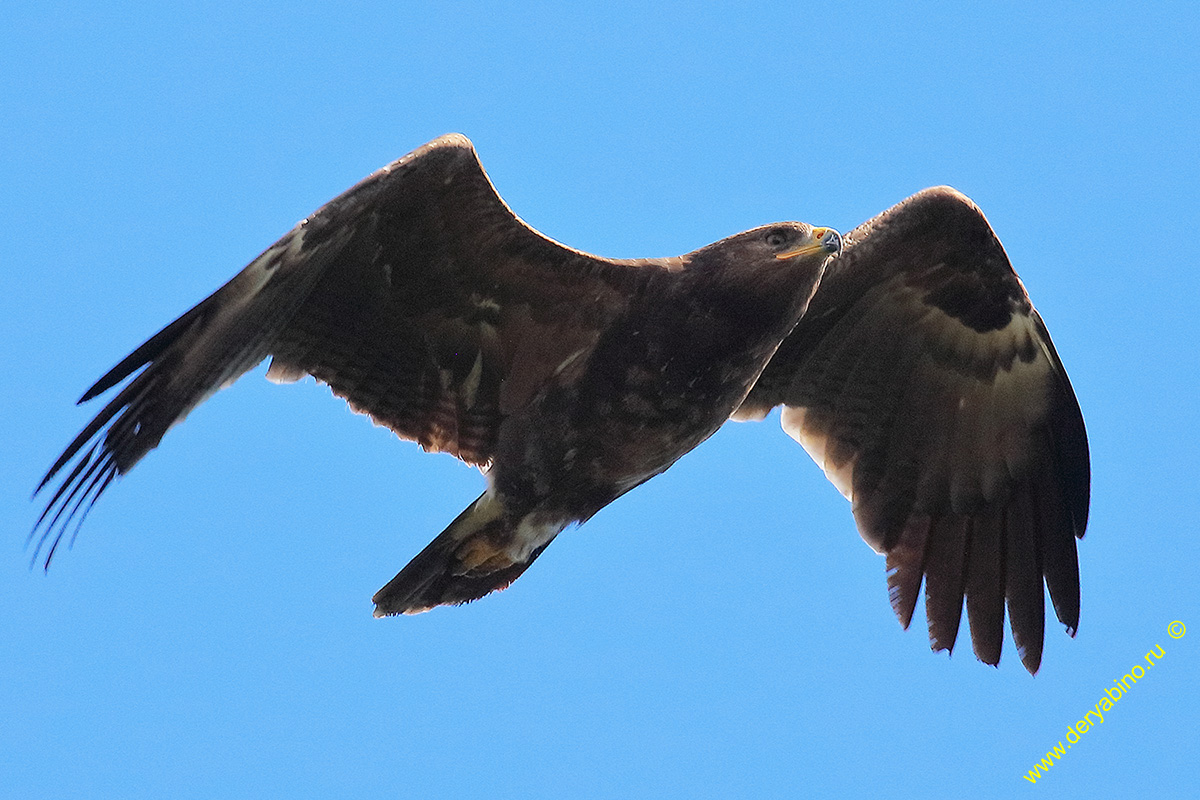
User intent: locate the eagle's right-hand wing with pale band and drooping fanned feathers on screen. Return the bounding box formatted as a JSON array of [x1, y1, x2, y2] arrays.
[[734, 187, 1090, 673]]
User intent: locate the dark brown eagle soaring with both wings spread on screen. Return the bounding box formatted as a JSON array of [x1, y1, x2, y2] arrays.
[[30, 134, 1090, 673]]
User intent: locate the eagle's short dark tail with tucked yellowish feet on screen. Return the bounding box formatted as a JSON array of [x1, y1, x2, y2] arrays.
[[371, 492, 570, 616]]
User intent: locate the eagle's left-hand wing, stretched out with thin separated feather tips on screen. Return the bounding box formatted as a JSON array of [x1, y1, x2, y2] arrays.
[[31, 134, 638, 565]]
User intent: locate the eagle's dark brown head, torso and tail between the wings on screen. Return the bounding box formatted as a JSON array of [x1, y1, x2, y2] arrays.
[[374, 223, 841, 615]]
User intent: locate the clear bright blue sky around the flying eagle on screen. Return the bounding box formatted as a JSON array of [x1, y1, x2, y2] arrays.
[[0, 0, 1200, 798]]
